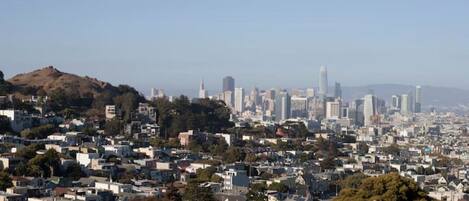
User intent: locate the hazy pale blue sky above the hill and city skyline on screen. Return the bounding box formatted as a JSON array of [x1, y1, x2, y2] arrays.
[[0, 0, 469, 95]]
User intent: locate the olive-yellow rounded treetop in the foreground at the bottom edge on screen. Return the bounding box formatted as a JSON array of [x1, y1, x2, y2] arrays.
[[334, 173, 431, 201]]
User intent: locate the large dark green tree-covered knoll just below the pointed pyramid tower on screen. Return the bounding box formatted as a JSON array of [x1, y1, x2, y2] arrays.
[[152, 96, 233, 138]]
